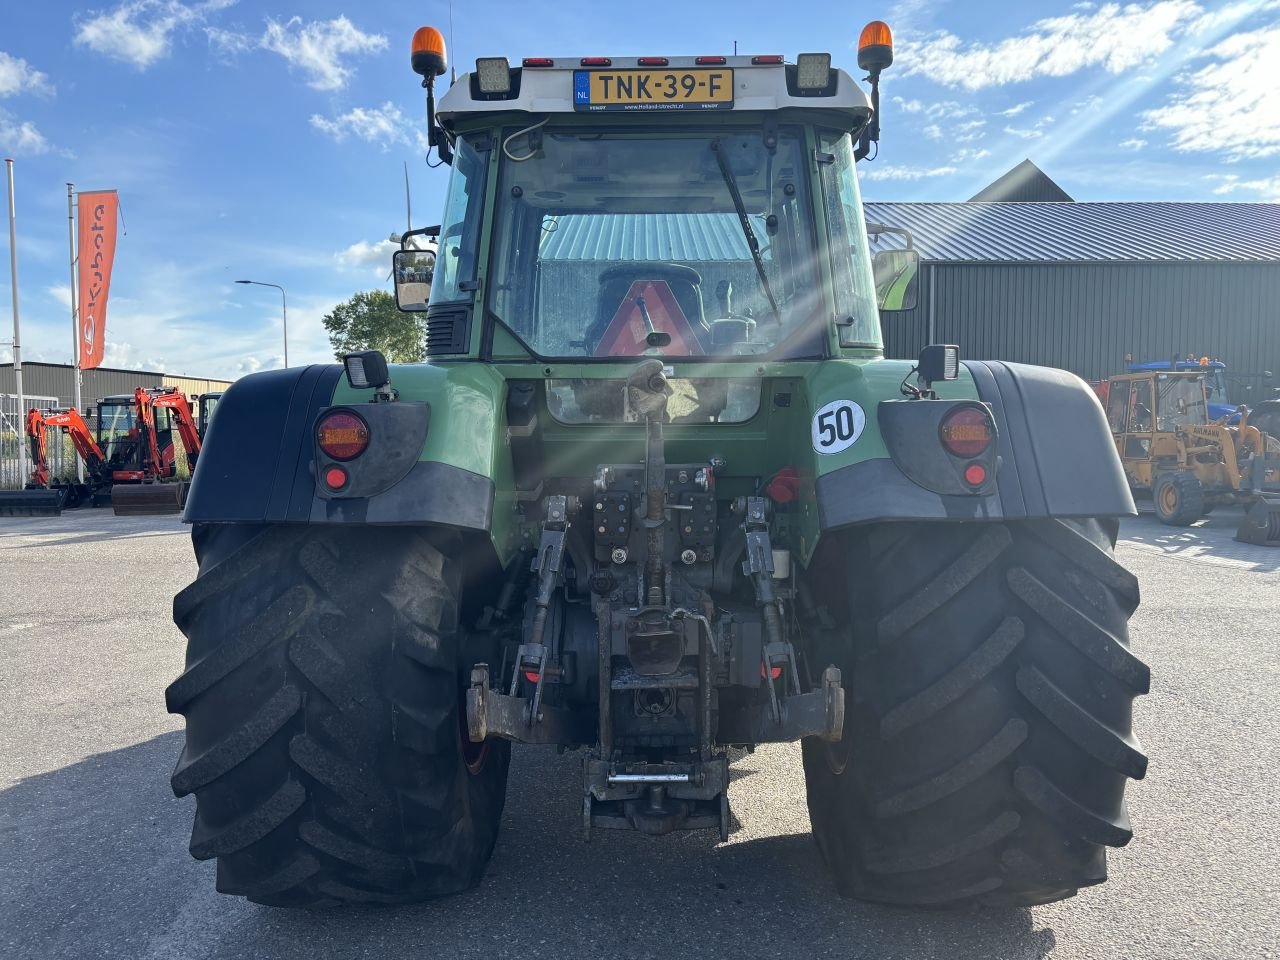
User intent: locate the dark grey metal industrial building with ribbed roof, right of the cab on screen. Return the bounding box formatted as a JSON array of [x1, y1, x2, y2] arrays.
[[867, 161, 1280, 403]]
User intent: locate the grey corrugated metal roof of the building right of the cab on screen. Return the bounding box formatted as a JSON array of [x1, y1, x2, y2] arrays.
[[867, 202, 1280, 262]]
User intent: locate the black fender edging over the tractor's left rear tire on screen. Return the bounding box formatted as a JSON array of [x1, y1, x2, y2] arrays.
[[183, 364, 494, 531]]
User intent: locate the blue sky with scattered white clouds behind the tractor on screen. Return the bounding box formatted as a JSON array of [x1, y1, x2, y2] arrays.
[[0, 0, 1280, 378]]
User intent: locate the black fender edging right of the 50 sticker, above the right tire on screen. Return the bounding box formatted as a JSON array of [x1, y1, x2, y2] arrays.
[[815, 360, 1138, 530]]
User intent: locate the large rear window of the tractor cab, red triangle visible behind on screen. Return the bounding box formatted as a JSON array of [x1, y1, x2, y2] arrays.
[[489, 129, 831, 358]]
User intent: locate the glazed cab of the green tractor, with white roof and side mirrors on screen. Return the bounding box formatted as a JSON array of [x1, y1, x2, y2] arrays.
[[394, 32, 915, 368]]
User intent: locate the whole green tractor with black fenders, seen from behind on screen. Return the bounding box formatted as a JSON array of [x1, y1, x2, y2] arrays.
[[166, 23, 1149, 906]]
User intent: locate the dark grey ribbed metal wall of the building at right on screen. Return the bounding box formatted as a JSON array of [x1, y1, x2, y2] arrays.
[[883, 262, 1280, 402]]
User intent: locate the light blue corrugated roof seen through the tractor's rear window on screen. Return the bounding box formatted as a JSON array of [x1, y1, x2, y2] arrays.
[[541, 214, 751, 262]]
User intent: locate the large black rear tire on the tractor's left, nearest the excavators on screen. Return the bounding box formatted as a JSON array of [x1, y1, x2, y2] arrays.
[[165, 525, 509, 906]]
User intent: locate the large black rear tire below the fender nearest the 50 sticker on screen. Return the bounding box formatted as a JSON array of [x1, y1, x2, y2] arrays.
[[804, 521, 1149, 906]]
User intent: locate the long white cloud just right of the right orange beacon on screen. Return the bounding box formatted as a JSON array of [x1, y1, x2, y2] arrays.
[[895, 0, 1203, 90]]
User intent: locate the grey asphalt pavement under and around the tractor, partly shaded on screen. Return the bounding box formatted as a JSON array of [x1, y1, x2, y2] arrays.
[[0, 509, 1280, 960]]
